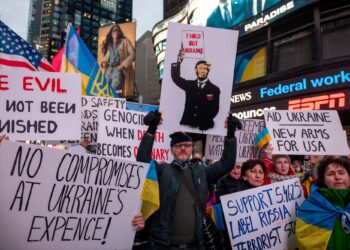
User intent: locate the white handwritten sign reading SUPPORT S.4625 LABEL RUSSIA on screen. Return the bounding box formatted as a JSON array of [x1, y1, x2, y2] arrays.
[[220, 178, 304, 250]]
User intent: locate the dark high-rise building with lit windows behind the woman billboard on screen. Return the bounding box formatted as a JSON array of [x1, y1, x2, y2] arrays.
[[33, 0, 132, 60]]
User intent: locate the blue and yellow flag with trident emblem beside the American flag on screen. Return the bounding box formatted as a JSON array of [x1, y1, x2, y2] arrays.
[[61, 24, 119, 97]]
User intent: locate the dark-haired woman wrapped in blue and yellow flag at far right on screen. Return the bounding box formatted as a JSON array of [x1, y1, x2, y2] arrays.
[[296, 157, 350, 250]]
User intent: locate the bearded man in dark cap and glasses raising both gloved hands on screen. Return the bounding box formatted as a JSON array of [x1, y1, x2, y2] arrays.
[[137, 112, 242, 250]]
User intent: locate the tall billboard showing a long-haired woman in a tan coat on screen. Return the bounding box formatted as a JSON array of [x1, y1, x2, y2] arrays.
[[97, 22, 136, 97]]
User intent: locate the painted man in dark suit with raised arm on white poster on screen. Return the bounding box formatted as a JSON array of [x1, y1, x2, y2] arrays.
[[171, 50, 220, 130]]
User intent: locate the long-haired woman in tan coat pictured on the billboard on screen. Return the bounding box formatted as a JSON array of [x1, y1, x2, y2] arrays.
[[101, 24, 135, 96]]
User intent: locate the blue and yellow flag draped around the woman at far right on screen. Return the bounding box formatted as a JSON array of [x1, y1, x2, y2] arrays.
[[296, 190, 350, 250]]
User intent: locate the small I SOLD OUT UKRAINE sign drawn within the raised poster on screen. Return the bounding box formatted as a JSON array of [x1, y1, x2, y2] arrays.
[[182, 30, 205, 58]]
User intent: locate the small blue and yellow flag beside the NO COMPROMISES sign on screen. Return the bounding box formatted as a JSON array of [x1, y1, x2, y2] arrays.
[[141, 159, 160, 220]]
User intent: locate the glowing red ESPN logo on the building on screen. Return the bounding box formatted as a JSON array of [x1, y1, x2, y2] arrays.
[[288, 92, 346, 110]]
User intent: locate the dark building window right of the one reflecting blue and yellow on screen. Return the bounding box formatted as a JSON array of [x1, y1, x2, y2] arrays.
[[272, 31, 314, 72]]
